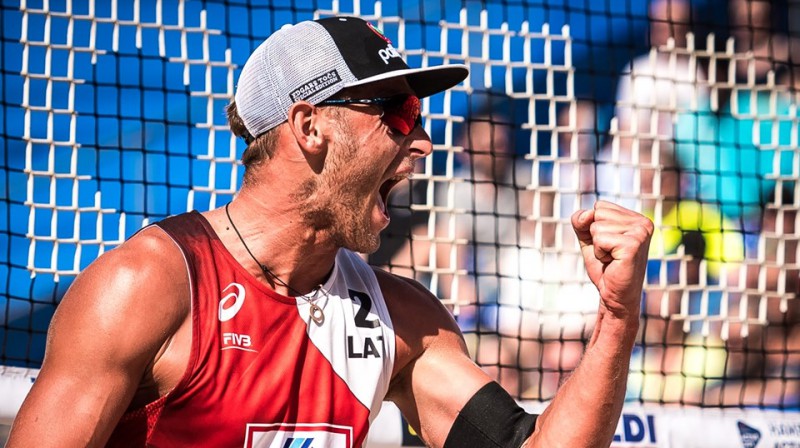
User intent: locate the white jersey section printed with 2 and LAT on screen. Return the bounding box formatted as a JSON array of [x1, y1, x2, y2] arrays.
[[297, 249, 395, 422]]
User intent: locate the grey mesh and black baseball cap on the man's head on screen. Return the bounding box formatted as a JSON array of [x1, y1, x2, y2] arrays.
[[235, 17, 469, 137]]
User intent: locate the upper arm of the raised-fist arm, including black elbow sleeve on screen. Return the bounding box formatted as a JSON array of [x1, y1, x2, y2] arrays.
[[378, 272, 536, 448]]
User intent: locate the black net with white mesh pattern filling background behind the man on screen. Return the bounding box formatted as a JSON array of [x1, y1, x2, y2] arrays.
[[0, 0, 800, 447]]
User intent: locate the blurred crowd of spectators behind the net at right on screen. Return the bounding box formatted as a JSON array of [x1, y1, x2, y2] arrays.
[[370, 0, 800, 409]]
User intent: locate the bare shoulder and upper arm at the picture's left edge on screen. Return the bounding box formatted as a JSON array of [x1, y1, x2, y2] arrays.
[[10, 231, 188, 446]]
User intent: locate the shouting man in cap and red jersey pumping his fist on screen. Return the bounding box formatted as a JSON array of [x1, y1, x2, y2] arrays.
[[9, 17, 652, 447]]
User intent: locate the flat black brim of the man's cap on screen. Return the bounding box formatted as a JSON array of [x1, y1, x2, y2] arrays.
[[346, 64, 469, 98]]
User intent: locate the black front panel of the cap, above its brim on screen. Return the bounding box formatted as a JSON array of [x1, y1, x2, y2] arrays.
[[317, 17, 408, 80]]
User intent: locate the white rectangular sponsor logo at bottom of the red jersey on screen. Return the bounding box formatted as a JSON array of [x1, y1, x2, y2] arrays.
[[244, 423, 353, 448]]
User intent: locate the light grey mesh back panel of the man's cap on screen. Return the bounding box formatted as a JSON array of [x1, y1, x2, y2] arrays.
[[231, 22, 357, 137]]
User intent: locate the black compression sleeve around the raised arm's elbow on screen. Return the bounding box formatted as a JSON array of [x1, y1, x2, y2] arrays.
[[444, 381, 538, 448]]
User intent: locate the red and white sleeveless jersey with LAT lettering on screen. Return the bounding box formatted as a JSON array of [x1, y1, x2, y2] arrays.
[[109, 212, 395, 448]]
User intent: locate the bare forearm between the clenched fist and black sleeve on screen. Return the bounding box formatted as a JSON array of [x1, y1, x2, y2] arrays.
[[527, 306, 639, 447]]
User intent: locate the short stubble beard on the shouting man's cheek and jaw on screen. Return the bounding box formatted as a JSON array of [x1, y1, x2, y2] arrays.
[[298, 120, 381, 254]]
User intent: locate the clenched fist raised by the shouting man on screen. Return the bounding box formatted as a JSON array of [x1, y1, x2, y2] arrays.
[[572, 201, 653, 318]]
